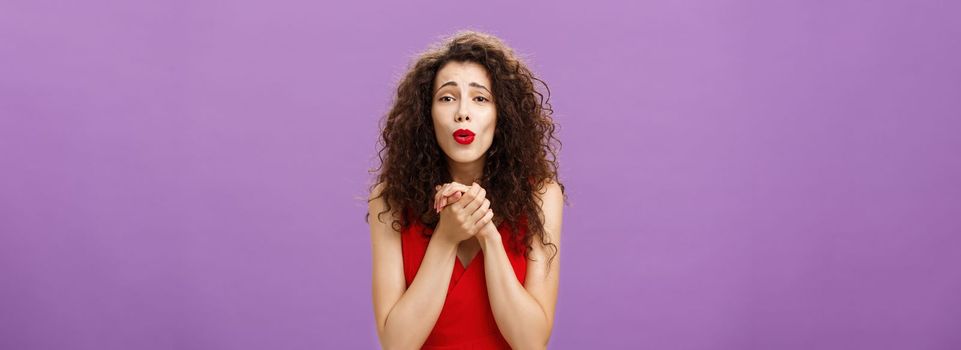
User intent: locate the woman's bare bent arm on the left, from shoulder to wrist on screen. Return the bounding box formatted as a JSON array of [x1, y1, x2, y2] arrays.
[[368, 184, 457, 349]]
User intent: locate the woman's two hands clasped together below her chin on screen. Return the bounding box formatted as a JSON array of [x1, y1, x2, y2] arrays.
[[435, 183, 494, 244]]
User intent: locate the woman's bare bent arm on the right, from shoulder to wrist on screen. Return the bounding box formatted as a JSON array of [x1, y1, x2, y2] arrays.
[[478, 182, 564, 349]]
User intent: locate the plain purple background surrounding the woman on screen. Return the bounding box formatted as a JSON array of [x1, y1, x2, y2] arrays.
[[0, 0, 961, 349]]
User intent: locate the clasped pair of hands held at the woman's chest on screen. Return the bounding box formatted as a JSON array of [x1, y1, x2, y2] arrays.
[[434, 182, 500, 244]]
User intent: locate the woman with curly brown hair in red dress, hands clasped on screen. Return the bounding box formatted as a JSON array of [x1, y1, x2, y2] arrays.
[[367, 31, 565, 349]]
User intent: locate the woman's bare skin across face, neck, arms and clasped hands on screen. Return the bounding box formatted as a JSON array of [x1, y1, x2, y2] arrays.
[[368, 62, 563, 349]]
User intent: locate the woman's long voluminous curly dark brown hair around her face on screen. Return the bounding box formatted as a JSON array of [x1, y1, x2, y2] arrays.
[[365, 30, 567, 263]]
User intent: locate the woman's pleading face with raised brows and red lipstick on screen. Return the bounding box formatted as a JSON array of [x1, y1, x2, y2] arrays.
[[430, 61, 497, 163]]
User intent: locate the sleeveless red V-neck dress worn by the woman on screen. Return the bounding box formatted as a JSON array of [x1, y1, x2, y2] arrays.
[[401, 206, 527, 350]]
